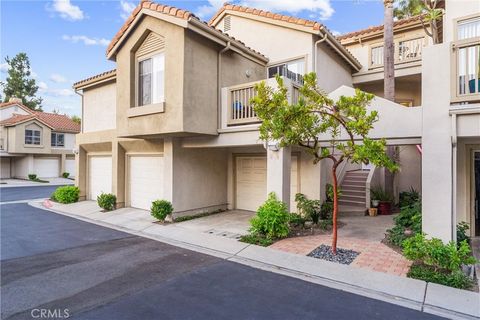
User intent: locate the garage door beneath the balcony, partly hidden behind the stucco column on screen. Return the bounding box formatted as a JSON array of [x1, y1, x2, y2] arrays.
[[236, 157, 298, 211]]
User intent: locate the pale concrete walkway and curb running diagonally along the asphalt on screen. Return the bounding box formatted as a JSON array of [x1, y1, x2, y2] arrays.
[[30, 201, 480, 319]]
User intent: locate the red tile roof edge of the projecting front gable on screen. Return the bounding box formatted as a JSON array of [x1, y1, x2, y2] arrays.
[[107, 0, 267, 60]]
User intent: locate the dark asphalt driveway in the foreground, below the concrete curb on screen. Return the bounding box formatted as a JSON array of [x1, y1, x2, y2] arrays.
[[0, 188, 444, 320]]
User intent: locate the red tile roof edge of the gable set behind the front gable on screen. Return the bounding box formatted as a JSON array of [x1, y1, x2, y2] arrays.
[[208, 2, 325, 30]]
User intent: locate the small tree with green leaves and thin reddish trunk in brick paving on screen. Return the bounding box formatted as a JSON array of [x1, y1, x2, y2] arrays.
[[252, 73, 398, 254]]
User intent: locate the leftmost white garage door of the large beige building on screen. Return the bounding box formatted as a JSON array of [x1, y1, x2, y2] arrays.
[[88, 156, 112, 200]]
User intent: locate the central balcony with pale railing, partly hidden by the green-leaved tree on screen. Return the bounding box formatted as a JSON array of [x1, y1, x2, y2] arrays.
[[220, 77, 301, 131]]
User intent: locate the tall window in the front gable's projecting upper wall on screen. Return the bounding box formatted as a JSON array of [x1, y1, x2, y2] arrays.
[[138, 53, 165, 106]]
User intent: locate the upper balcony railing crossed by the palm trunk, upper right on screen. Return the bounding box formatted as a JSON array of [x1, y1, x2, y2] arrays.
[[370, 37, 427, 69]]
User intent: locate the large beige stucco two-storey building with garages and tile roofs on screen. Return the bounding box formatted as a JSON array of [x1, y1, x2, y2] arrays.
[[74, 1, 480, 240]]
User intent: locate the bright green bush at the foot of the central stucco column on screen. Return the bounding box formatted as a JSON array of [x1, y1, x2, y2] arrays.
[[250, 192, 289, 239]]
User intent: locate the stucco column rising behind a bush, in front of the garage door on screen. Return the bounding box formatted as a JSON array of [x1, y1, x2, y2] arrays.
[[267, 146, 292, 210]]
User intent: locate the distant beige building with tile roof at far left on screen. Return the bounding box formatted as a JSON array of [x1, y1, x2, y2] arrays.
[[0, 99, 80, 179]]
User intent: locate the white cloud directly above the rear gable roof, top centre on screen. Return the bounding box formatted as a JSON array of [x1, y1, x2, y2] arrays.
[[195, 0, 335, 20]]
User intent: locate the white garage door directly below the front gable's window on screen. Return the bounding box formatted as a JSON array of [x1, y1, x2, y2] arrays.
[[129, 156, 164, 210]]
